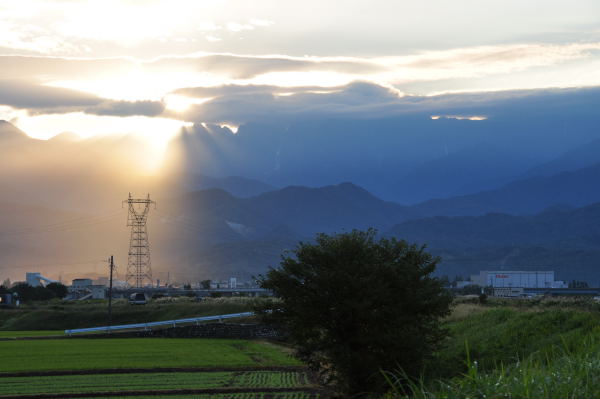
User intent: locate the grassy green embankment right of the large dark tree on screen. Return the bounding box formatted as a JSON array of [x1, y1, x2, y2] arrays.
[[390, 299, 600, 399]]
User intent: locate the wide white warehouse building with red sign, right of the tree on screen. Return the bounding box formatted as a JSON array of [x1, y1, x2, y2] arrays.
[[471, 270, 567, 288]]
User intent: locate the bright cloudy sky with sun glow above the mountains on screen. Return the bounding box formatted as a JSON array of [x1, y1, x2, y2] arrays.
[[0, 0, 600, 148]]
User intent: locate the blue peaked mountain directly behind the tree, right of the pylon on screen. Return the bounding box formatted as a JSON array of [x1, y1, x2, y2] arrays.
[[159, 183, 412, 278]]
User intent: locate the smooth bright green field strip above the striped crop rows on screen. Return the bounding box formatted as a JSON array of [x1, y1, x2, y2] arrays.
[[0, 338, 300, 372]]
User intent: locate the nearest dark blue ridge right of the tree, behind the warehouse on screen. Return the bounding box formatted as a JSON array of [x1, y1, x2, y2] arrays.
[[387, 203, 600, 284]]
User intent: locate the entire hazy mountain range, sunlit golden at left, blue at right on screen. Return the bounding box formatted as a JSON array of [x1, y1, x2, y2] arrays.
[[0, 89, 600, 282]]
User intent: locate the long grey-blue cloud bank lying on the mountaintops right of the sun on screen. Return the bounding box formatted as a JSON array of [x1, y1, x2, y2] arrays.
[[176, 82, 599, 125]]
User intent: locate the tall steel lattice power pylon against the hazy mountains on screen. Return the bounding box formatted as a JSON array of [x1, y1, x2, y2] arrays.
[[123, 193, 156, 288]]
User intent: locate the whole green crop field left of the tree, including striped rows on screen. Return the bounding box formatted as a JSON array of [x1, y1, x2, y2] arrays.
[[0, 338, 319, 399]]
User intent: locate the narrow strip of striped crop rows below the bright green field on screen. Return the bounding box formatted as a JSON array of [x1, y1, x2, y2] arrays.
[[0, 371, 303, 397]]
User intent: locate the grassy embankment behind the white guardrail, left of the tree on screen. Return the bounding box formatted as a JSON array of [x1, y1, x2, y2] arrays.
[[0, 297, 261, 331]]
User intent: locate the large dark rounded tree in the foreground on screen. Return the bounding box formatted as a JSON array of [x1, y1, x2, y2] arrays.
[[259, 230, 451, 396]]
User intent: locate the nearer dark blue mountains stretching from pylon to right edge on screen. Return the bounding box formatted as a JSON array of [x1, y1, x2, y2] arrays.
[[163, 173, 600, 278]]
